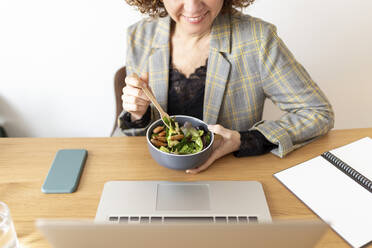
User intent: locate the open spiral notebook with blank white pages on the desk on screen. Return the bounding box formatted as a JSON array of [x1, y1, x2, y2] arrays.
[[274, 137, 372, 247]]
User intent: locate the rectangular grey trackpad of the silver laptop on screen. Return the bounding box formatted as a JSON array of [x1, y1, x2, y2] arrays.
[[156, 184, 210, 210]]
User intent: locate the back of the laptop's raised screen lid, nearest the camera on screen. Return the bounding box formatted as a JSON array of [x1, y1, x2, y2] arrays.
[[36, 220, 327, 248]]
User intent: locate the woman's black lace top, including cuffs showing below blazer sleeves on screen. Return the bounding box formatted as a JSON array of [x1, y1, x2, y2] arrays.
[[123, 60, 276, 157]]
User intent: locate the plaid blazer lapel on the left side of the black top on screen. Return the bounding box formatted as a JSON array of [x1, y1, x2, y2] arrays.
[[148, 16, 170, 111]]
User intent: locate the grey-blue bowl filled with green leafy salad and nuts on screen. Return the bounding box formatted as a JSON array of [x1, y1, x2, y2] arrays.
[[146, 115, 214, 170]]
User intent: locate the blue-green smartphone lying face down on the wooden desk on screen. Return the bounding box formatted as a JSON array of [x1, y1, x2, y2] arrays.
[[41, 149, 88, 194]]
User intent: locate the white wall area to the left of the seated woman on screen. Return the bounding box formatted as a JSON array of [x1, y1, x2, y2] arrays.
[[0, 0, 140, 137]]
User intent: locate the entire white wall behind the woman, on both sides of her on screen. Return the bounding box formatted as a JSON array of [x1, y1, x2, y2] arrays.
[[0, 0, 372, 137]]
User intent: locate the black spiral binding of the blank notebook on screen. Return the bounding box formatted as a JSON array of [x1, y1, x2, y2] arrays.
[[321, 152, 372, 193]]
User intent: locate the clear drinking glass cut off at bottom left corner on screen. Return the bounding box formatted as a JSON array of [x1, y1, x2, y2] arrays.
[[0, 202, 19, 248]]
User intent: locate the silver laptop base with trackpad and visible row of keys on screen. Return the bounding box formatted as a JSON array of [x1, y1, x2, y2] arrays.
[[95, 181, 271, 223]]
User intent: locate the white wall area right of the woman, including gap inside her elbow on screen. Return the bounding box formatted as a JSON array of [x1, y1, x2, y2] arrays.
[[247, 0, 372, 126]]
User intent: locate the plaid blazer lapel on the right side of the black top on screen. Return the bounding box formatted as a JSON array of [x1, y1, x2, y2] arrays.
[[203, 14, 231, 124]]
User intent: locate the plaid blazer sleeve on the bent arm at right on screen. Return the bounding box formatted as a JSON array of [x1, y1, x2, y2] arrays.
[[252, 24, 334, 157]]
